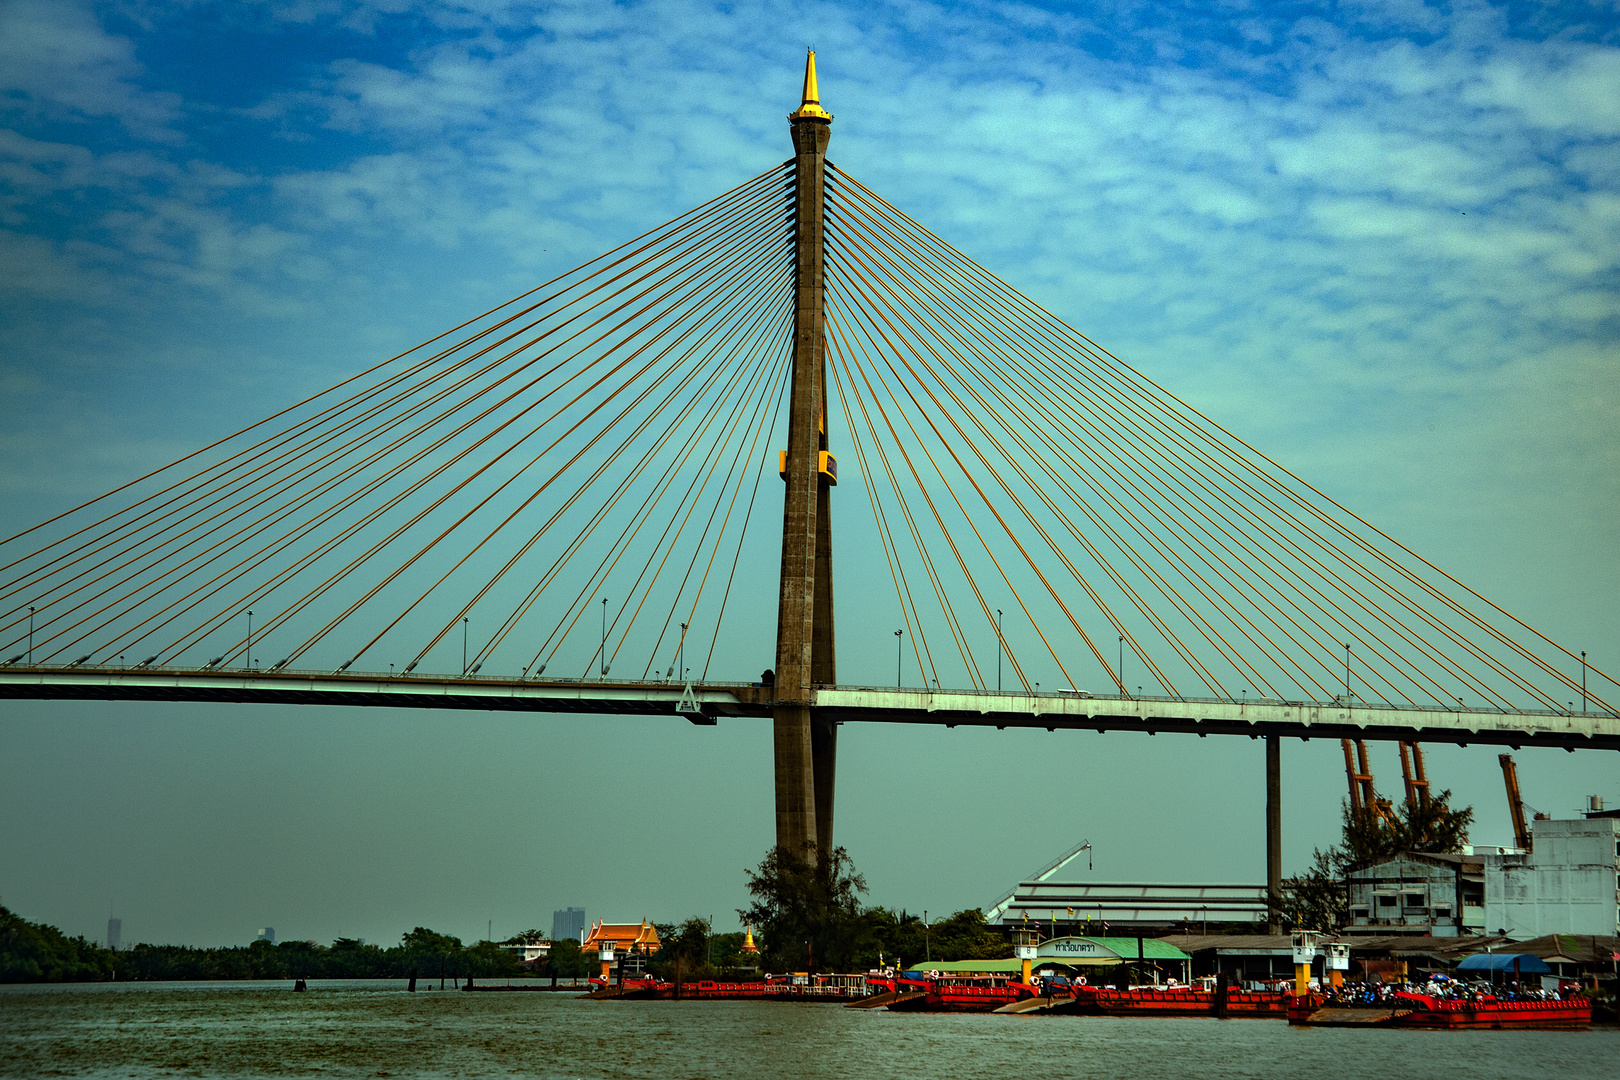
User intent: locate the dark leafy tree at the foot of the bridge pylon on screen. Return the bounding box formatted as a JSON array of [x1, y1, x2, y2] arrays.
[[737, 847, 876, 972]]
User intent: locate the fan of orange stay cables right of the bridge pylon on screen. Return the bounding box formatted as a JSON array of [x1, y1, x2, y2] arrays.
[[826, 165, 1615, 712]]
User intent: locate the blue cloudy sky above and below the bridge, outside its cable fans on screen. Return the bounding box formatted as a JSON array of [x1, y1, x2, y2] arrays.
[[0, 0, 1620, 941]]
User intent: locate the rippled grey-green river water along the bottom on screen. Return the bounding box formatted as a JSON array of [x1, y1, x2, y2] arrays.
[[0, 981, 1620, 1080]]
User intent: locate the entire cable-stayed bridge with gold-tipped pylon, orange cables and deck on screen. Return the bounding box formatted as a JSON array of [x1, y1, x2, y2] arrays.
[[0, 57, 1620, 906]]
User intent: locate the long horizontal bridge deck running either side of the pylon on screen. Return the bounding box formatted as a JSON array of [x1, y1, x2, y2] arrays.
[[0, 665, 1620, 750]]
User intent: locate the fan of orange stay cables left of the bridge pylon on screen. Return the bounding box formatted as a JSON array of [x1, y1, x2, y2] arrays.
[[0, 167, 792, 678]]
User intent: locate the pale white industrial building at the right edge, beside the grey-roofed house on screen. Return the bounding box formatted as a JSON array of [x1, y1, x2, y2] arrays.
[[1476, 811, 1620, 939]]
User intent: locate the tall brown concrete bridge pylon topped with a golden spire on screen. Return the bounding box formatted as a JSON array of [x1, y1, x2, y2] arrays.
[[773, 52, 838, 855]]
